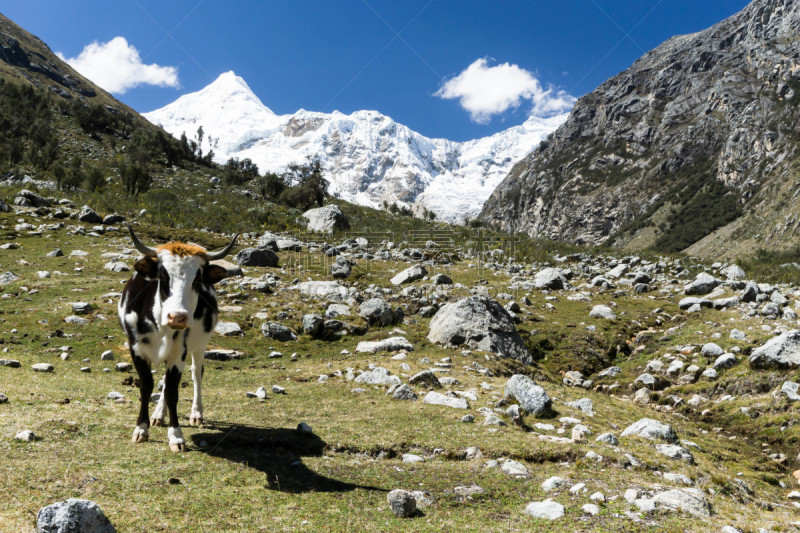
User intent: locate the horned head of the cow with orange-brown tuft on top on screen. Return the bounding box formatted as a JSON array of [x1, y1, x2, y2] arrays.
[[128, 226, 239, 329]]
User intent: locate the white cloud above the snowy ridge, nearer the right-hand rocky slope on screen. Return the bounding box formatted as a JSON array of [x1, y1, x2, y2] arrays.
[[434, 58, 576, 124]]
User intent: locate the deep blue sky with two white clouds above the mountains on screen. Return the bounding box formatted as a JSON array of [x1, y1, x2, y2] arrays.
[[0, 0, 748, 141]]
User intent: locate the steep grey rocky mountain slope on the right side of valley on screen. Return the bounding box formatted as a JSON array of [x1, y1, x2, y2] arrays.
[[480, 0, 800, 256]]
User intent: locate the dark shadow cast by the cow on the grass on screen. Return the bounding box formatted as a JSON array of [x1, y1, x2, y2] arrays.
[[190, 421, 386, 494]]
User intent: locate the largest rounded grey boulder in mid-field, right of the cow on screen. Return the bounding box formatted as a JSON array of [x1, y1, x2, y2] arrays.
[[428, 295, 533, 364]]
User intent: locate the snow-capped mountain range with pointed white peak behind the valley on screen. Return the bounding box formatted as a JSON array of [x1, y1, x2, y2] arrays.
[[144, 72, 567, 222]]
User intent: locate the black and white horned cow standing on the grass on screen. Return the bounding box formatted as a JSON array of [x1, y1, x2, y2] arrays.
[[118, 226, 239, 452]]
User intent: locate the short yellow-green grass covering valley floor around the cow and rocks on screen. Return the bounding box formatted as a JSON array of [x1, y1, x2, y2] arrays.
[[0, 210, 797, 531]]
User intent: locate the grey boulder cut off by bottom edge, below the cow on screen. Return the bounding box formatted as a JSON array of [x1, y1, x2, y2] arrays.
[[36, 498, 117, 533]]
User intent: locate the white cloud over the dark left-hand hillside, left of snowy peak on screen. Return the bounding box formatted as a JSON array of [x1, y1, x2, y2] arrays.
[[57, 37, 180, 94]]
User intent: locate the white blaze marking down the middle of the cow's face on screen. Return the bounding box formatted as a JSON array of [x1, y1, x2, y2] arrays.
[[158, 250, 206, 329]]
